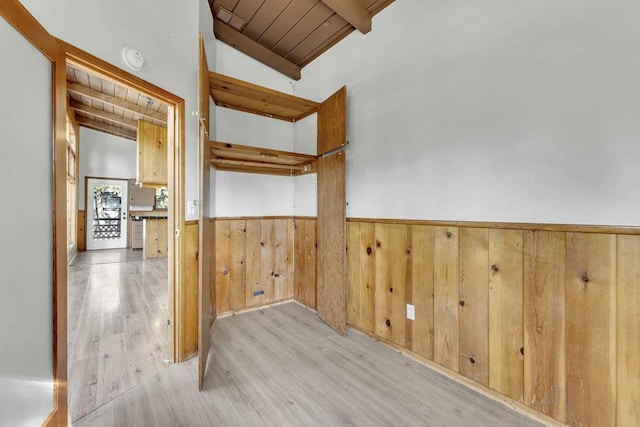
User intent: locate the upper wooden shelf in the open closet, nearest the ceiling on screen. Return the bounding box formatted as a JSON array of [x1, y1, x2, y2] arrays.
[[209, 72, 320, 122]]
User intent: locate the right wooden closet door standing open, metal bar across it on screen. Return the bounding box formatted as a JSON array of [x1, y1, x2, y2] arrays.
[[317, 87, 347, 334]]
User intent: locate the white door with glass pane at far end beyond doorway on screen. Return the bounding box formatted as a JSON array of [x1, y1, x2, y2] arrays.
[[85, 178, 129, 250]]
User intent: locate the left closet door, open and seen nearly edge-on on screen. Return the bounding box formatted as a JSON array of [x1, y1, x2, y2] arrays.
[[198, 35, 215, 390]]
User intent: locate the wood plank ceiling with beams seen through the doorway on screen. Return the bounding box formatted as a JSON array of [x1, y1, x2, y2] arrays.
[[67, 64, 167, 141]]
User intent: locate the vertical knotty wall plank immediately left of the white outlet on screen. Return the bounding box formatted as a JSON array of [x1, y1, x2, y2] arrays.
[[387, 224, 411, 346]]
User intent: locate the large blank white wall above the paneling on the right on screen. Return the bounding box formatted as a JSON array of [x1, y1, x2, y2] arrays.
[[296, 0, 640, 225]]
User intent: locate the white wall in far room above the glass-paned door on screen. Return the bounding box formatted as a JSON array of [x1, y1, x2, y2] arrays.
[[78, 127, 137, 210]]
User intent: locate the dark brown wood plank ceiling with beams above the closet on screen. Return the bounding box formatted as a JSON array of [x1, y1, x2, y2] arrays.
[[209, 0, 393, 80]]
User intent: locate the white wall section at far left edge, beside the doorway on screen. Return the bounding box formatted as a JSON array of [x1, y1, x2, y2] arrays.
[[0, 18, 53, 427]]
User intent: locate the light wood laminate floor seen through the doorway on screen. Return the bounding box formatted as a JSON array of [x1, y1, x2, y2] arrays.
[[67, 249, 169, 420]]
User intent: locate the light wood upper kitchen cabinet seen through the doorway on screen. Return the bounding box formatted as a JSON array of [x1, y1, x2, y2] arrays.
[[136, 120, 168, 187]]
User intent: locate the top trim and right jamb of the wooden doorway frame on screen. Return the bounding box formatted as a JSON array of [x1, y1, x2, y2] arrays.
[[56, 39, 186, 362]]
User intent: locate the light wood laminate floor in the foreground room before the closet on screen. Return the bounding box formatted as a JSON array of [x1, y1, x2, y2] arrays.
[[74, 303, 539, 427]]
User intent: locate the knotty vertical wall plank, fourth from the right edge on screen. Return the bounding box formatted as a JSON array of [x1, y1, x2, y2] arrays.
[[489, 230, 524, 402]]
